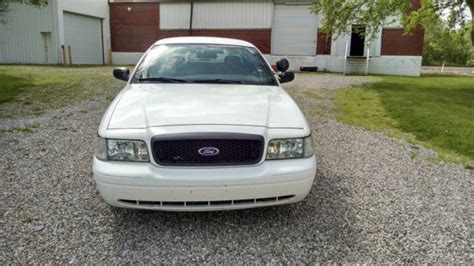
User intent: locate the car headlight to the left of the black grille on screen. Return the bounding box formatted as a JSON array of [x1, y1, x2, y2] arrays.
[[95, 138, 149, 162]]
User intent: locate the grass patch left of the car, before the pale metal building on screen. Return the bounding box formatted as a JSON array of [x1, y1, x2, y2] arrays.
[[0, 65, 124, 117]]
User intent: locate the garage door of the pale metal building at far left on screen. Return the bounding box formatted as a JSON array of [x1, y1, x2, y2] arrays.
[[64, 12, 103, 65]]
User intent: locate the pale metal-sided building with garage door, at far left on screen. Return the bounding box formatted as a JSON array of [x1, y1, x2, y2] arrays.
[[0, 0, 110, 64]]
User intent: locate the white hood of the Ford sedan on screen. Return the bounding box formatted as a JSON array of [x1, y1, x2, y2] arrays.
[[108, 84, 305, 129]]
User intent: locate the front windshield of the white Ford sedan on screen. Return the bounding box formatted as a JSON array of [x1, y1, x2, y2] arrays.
[[132, 44, 277, 85]]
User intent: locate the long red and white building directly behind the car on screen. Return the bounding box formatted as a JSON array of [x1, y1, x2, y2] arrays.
[[110, 0, 424, 76]]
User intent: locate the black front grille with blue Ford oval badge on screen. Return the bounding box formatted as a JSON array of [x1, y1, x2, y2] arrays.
[[152, 133, 264, 166]]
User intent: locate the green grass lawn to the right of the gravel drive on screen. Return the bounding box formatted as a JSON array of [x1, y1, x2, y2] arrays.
[[335, 75, 474, 166]]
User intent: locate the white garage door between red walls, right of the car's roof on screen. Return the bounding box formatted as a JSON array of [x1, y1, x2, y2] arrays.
[[272, 5, 318, 55]]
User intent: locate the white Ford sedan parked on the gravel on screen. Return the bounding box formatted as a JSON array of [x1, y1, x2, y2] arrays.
[[93, 37, 316, 211]]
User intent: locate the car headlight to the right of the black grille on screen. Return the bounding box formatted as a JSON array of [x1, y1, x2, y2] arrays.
[[267, 136, 314, 160]]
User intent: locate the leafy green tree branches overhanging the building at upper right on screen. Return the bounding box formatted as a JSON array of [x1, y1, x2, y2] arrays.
[[311, 0, 474, 45]]
